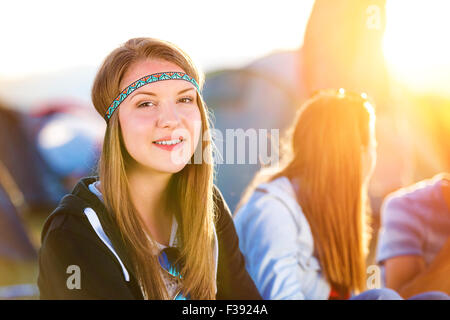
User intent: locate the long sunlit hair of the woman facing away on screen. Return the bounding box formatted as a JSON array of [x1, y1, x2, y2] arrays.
[[237, 90, 375, 294]]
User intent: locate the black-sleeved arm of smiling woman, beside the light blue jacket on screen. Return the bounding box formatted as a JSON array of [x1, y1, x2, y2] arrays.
[[214, 187, 261, 300]]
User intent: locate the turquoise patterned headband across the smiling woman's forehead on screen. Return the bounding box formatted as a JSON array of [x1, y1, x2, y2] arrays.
[[105, 71, 200, 123]]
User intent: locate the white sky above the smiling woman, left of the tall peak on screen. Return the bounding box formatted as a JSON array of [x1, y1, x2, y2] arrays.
[[0, 0, 314, 80]]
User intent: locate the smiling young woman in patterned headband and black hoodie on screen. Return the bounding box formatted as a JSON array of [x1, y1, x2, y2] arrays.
[[38, 38, 261, 299]]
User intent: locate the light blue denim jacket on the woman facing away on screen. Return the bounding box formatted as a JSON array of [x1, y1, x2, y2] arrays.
[[234, 177, 330, 300]]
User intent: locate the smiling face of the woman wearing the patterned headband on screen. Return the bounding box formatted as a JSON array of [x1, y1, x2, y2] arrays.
[[118, 60, 201, 173]]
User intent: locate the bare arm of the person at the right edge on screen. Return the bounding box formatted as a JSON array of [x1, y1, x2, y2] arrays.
[[385, 238, 450, 299]]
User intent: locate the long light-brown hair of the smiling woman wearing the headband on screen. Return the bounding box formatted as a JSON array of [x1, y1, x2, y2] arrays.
[[92, 38, 215, 299]]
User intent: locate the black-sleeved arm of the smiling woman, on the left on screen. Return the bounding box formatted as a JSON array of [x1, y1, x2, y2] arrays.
[[38, 220, 135, 300]]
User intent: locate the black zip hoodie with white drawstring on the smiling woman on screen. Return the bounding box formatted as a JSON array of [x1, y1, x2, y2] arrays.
[[38, 176, 261, 300]]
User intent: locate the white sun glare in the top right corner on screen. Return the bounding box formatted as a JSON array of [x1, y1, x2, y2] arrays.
[[383, 0, 450, 95]]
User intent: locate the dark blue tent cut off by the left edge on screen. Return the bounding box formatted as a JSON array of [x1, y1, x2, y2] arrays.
[[0, 106, 50, 262]]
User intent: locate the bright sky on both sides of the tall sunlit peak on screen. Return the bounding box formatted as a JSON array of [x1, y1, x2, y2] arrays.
[[0, 0, 450, 105]]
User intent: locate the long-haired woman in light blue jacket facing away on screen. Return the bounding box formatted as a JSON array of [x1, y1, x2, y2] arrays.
[[235, 89, 376, 299]]
